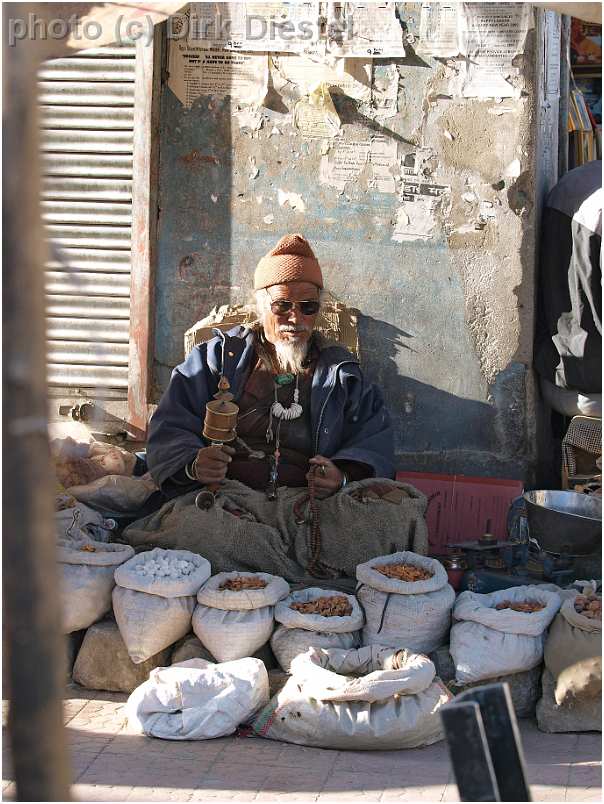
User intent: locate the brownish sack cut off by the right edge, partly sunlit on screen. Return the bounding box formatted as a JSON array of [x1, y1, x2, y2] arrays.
[[544, 595, 602, 706]]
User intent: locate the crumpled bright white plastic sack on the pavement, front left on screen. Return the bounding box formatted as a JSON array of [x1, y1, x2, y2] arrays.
[[126, 659, 269, 740]]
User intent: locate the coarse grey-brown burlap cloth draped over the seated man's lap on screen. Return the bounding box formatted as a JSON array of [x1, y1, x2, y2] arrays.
[[123, 478, 428, 582]]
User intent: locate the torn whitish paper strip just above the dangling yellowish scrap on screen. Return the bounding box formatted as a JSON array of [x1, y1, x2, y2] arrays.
[[272, 54, 371, 101]]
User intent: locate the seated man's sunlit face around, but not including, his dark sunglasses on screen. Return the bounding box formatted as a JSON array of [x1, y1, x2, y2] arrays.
[[263, 282, 319, 344]]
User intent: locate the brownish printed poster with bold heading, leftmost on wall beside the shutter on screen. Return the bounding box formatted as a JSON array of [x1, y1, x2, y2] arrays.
[[168, 41, 268, 109]]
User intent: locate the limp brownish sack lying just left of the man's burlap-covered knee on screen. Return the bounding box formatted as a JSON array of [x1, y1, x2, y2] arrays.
[[67, 473, 158, 516]]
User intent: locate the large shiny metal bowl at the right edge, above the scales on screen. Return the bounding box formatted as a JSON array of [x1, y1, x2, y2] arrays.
[[523, 491, 602, 556]]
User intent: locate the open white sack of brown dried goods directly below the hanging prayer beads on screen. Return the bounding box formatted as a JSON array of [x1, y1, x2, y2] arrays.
[[271, 587, 364, 673]]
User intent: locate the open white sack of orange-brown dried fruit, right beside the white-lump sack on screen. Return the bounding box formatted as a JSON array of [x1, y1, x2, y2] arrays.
[[193, 572, 289, 662]]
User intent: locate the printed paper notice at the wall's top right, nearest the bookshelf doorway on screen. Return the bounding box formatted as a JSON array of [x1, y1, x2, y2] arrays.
[[459, 3, 533, 98]]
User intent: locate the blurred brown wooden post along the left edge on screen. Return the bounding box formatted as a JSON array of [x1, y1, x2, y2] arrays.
[[2, 3, 69, 801]]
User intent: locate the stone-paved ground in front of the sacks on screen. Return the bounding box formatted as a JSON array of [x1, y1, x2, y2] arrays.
[[2, 685, 601, 802]]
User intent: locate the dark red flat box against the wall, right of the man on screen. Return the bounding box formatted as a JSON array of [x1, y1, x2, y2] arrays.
[[396, 472, 523, 555]]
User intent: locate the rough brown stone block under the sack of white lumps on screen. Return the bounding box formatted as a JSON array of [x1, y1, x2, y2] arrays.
[[73, 620, 171, 692]]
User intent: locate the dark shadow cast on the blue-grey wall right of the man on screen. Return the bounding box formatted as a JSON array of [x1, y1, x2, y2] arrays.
[[358, 315, 526, 479]]
